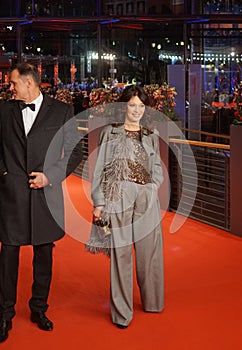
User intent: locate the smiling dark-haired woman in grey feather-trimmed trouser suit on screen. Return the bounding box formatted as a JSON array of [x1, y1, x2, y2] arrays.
[[87, 86, 164, 329]]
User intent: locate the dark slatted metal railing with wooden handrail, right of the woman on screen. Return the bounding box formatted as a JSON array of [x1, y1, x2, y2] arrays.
[[169, 138, 230, 230]]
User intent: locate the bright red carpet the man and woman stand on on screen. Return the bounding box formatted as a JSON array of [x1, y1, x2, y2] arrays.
[[0, 176, 242, 350]]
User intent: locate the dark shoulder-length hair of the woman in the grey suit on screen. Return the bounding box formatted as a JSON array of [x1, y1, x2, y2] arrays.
[[116, 85, 154, 130]]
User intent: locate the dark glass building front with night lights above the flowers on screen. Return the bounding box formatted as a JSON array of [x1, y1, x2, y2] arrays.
[[0, 0, 242, 92]]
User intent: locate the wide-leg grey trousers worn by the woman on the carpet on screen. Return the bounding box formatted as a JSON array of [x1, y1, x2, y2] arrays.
[[110, 182, 164, 326]]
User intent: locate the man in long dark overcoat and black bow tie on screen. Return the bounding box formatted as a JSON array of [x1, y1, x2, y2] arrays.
[[0, 63, 82, 342]]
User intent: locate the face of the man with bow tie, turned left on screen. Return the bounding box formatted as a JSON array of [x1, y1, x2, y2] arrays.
[[10, 69, 28, 101]]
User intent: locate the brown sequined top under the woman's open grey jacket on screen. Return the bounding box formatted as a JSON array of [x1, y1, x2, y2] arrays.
[[125, 130, 152, 185]]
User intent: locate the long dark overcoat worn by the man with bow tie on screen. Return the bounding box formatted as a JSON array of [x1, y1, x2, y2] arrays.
[[0, 95, 82, 245]]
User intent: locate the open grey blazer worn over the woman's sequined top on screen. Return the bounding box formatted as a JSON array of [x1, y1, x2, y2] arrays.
[[91, 124, 163, 207]]
